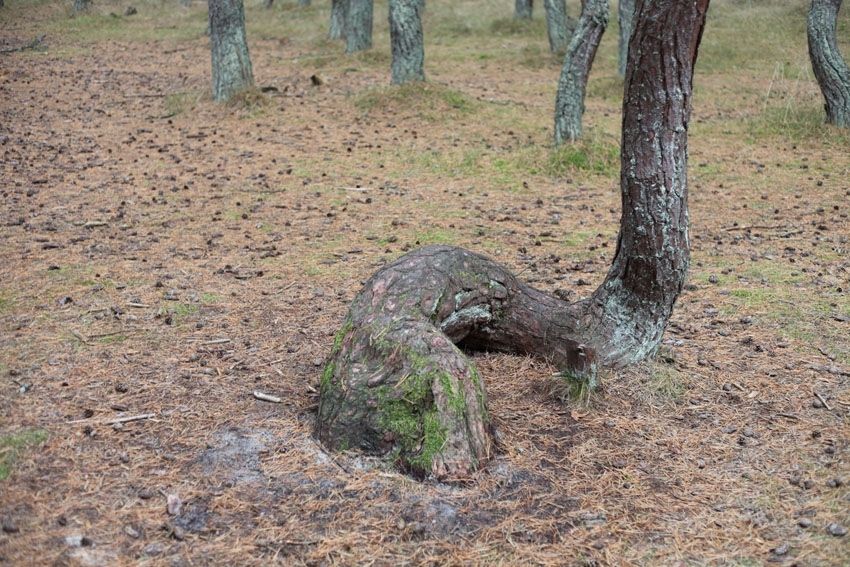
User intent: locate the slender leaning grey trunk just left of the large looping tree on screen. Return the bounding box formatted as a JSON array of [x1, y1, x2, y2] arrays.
[[555, 0, 608, 146]]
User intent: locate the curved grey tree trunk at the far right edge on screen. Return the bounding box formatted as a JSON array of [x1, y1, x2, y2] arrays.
[[808, 0, 850, 128]]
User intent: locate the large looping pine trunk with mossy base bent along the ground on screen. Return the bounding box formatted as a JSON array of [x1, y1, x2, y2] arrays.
[[315, 0, 708, 479]]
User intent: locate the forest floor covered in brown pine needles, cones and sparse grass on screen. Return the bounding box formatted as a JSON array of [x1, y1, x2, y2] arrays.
[[0, 0, 850, 566]]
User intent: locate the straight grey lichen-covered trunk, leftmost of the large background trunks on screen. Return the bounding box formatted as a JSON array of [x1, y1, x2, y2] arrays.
[[209, 0, 254, 101]]
